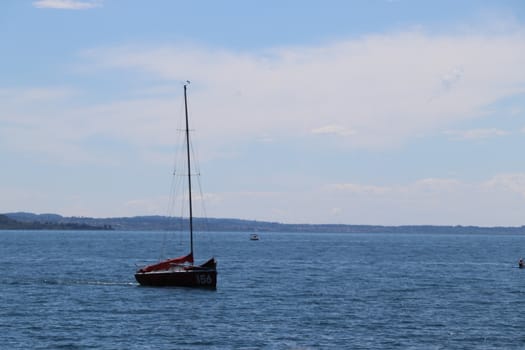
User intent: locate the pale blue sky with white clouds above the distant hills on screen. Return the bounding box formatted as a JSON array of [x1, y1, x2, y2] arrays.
[[0, 0, 525, 226]]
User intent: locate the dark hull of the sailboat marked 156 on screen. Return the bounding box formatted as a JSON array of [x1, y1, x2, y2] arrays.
[[135, 270, 217, 289]]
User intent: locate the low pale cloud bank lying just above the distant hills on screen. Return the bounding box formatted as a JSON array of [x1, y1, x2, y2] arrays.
[[4, 169, 525, 226]]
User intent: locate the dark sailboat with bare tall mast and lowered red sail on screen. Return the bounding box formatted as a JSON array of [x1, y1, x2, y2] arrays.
[[135, 81, 217, 289]]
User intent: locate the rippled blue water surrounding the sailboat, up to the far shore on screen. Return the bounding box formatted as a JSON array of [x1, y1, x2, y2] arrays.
[[0, 231, 525, 349]]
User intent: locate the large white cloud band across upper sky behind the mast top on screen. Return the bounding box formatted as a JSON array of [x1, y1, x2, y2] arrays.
[[4, 26, 525, 165]]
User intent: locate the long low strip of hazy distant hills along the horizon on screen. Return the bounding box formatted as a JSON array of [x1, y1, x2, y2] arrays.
[[0, 212, 525, 234]]
